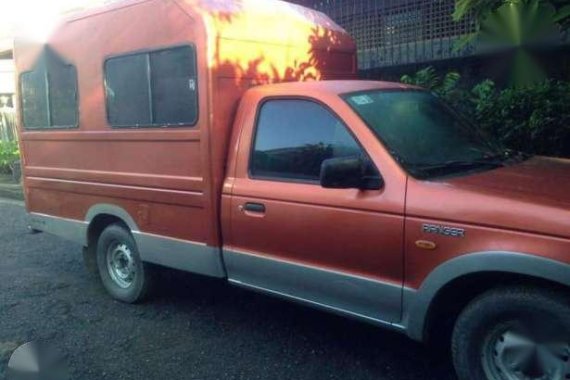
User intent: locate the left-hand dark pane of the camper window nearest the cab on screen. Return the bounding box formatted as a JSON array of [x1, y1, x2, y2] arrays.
[[105, 54, 152, 126]]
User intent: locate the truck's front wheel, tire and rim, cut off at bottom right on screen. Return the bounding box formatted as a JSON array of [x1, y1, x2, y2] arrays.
[[452, 287, 570, 380]]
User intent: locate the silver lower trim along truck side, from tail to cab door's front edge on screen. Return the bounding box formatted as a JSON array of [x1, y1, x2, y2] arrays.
[[29, 213, 405, 331]]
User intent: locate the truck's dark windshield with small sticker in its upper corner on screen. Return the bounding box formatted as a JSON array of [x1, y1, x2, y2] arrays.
[[344, 90, 506, 178]]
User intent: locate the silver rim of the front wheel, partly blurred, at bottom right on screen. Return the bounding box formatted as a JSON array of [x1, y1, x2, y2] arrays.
[[482, 321, 570, 380]]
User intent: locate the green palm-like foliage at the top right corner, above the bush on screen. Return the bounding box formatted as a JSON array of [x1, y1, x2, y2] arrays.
[[453, 0, 570, 86]]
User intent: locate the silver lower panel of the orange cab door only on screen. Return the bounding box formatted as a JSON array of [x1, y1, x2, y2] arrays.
[[223, 250, 403, 330]]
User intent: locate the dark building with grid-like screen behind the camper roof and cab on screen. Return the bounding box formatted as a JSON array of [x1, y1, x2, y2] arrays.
[[291, 0, 570, 79]]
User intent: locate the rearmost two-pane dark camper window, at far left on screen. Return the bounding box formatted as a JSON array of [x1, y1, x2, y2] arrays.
[[20, 48, 78, 129]]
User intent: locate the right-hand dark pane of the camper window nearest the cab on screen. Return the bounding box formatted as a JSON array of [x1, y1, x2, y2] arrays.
[[150, 47, 198, 124]]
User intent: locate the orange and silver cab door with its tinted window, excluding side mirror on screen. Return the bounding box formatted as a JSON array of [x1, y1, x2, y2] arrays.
[[223, 98, 405, 323]]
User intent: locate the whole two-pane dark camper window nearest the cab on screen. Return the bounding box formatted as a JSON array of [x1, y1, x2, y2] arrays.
[[105, 46, 198, 127]]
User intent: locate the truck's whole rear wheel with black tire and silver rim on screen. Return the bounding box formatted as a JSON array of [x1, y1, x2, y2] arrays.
[[97, 224, 152, 303]]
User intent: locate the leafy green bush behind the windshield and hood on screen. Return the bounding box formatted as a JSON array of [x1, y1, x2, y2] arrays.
[[401, 68, 570, 158]]
